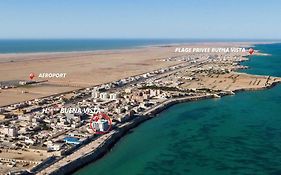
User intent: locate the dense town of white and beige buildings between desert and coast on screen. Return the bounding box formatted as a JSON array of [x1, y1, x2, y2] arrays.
[[0, 52, 247, 174]]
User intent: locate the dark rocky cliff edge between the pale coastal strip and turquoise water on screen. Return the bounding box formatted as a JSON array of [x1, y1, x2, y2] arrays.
[[41, 81, 281, 175]]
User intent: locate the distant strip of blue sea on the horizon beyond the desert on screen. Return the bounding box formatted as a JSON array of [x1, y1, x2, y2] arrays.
[[0, 39, 276, 54]]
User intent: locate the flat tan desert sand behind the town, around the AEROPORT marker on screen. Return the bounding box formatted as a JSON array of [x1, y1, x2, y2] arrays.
[[0, 43, 254, 106]]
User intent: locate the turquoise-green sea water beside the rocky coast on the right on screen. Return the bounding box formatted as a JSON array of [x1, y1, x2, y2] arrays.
[[75, 44, 281, 175]]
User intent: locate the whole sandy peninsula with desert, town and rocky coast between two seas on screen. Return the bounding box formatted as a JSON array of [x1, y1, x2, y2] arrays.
[[0, 43, 281, 174]]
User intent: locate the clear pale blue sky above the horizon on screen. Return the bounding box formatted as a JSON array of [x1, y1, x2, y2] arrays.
[[0, 0, 281, 39]]
